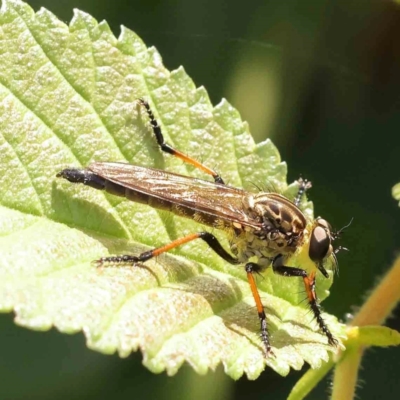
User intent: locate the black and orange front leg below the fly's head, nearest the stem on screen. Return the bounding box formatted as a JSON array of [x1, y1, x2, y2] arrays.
[[272, 255, 338, 346]]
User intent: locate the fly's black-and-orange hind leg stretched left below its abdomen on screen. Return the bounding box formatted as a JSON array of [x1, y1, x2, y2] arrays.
[[96, 232, 239, 266]]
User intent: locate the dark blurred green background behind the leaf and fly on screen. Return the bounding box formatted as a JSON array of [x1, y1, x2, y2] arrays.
[[0, 0, 400, 400]]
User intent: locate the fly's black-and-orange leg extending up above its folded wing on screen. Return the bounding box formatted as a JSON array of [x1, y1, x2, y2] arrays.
[[137, 99, 225, 185]]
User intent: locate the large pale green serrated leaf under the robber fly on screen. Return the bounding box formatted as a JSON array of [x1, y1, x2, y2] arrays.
[[0, 0, 343, 379]]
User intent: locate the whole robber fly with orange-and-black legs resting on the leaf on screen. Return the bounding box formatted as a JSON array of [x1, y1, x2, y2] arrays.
[[57, 99, 343, 354]]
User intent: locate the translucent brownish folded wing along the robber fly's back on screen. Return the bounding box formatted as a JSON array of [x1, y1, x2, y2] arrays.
[[88, 162, 260, 228]]
